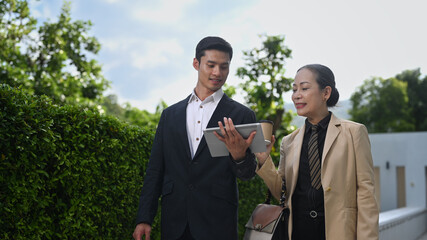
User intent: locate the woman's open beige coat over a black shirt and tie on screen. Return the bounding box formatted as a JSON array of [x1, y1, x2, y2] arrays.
[[257, 114, 379, 240]]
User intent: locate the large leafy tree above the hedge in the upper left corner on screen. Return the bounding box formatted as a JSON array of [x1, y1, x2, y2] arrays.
[[0, 0, 108, 105]]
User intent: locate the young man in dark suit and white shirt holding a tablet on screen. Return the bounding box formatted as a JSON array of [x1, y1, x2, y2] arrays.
[[133, 37, 256, 240]]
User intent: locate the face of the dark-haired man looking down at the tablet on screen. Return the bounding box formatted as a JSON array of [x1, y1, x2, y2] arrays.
[[193, 50, 230, 94]]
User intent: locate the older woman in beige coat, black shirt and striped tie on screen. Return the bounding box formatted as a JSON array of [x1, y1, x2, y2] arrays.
[[257, 64, 379, 240]]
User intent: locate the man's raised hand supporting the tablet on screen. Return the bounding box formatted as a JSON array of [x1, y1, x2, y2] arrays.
[[214, 117, 256, 160]]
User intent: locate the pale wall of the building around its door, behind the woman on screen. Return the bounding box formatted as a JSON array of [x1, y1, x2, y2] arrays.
[[369, 132, 427, 212]]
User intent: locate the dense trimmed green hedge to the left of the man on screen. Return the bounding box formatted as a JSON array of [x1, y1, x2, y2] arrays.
[[0, 85, 157, 239]]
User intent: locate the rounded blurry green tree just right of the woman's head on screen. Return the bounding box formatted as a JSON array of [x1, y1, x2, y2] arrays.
[[350, 78, 415, 132]]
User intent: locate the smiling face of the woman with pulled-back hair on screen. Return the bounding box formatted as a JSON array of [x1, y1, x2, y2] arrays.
[[292, 68, 331, 124]]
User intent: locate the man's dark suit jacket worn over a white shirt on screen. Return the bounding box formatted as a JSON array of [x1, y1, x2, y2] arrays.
[[136, 94, 256, 240]]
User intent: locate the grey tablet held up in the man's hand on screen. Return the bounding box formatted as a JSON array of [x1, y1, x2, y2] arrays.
[[203, 123, 268, 157]]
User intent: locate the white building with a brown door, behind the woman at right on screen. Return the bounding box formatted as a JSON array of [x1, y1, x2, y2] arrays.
[[369, 132, 427, 240]]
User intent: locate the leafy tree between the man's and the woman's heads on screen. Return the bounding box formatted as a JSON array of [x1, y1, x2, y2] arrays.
[[237, 35, 295, 160]]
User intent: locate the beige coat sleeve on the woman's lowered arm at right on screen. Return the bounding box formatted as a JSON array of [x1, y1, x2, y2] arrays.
[[353, 125, 379, 240]]
